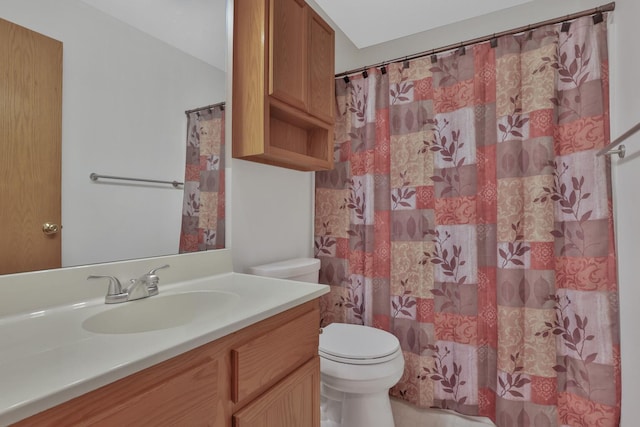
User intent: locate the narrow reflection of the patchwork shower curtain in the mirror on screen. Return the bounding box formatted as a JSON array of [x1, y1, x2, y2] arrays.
[[180, 106, 225, 253]]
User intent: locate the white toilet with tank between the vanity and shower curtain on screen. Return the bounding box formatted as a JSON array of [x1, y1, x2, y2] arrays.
[[249, 258, 404, 427]]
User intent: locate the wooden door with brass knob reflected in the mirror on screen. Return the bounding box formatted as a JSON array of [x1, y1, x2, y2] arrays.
[[0, 19, 62, 274]]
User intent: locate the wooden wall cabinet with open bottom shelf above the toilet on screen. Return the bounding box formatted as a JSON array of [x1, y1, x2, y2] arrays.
[[232, 0, 335, 171]]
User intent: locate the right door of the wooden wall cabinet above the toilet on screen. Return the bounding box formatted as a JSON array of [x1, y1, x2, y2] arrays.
[[308, 8, 335, 123]]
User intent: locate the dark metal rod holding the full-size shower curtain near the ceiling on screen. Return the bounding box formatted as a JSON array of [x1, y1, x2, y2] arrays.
[[336, 2, 616, 78]]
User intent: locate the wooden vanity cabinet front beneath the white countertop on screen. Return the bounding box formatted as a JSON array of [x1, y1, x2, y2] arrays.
[[16, 300, 320, 427]]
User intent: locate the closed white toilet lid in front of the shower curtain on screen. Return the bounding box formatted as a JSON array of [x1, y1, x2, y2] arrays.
[[319, 323, 400, 364]]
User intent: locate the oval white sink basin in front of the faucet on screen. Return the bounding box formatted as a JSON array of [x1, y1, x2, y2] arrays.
[[82, 291, 240, 334]]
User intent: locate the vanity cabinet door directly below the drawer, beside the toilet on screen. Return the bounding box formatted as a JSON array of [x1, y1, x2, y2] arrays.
[[233, 356, 320, 427]]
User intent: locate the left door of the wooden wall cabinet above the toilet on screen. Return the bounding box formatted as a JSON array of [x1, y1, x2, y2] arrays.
[[269, 0, 308, 111]]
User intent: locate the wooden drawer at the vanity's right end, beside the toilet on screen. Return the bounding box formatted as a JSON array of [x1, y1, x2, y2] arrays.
[[231, 309, 320, 403]]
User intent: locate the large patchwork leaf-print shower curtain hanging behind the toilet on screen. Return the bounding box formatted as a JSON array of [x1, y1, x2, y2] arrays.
[[315, 17, 621, 427]]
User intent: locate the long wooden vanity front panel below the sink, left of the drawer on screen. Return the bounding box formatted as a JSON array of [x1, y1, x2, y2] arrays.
[[12, 344, 225, 427]]
